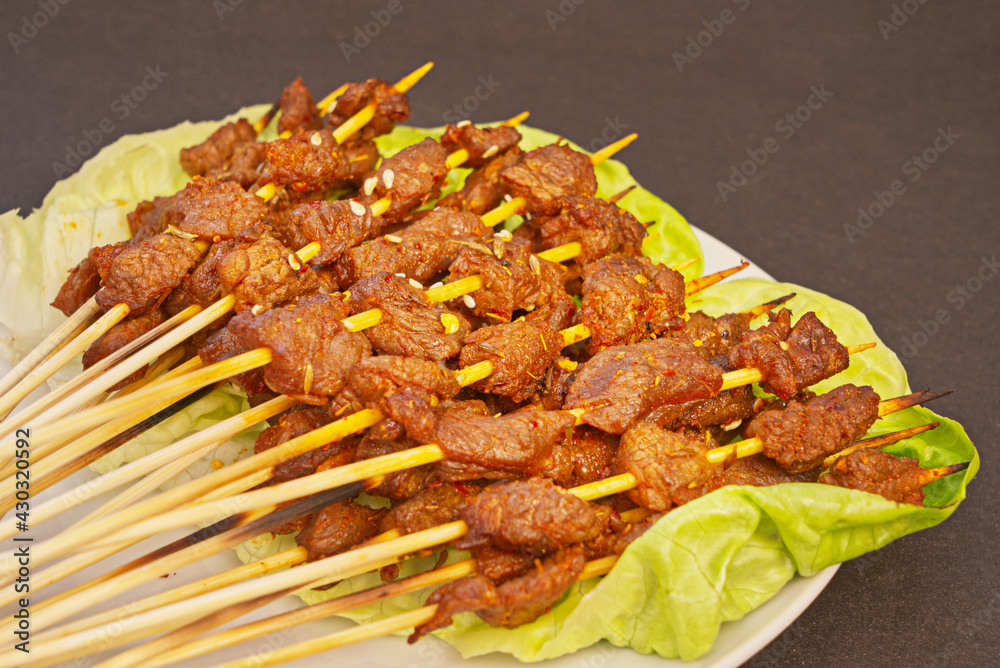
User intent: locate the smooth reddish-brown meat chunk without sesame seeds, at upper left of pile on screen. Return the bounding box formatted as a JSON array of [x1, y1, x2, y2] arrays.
[[160, 178, 268, 239]]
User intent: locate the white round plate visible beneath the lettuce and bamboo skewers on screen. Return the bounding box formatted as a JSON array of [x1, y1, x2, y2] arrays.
[[0, 228, 837, 668]]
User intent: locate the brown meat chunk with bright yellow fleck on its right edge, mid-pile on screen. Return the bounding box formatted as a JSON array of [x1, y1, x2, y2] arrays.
[[347, 271, 471, 360]]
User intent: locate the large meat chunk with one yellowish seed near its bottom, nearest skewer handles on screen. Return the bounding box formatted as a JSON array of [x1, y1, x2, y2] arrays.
[[227, 295, 371, 404]]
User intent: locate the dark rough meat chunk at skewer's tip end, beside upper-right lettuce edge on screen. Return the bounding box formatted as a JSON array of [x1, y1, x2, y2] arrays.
[[531, 195, 646, 265]]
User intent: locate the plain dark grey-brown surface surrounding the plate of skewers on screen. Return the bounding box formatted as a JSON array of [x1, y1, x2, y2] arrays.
[[0, 0, 1000, 666]]
